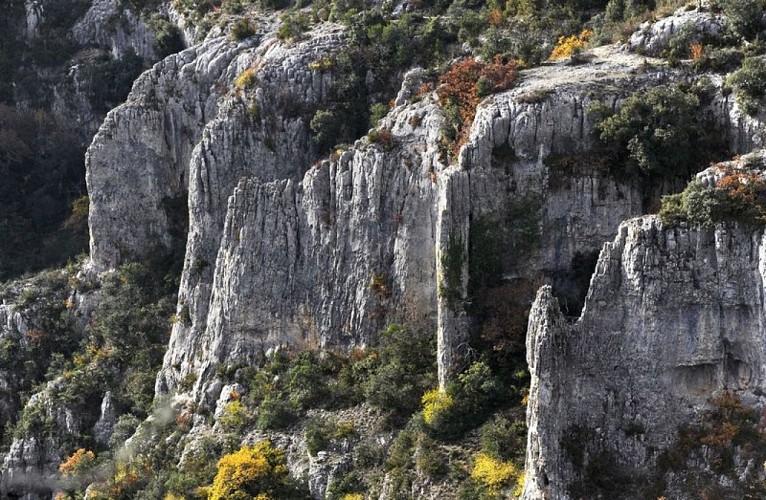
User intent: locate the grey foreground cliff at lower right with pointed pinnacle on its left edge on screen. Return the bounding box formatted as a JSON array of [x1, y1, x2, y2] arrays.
[[524, 217, 766, 499]]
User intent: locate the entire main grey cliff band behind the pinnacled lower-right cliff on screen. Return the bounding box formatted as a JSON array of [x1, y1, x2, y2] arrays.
[[88, 24, 759, 410]]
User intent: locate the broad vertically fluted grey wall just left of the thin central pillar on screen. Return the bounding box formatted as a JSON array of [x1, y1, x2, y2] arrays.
[[165, 93, 442, 397]]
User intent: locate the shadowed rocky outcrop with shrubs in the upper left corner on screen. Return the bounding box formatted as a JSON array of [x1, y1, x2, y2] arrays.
[[13, 0, 177, 148]]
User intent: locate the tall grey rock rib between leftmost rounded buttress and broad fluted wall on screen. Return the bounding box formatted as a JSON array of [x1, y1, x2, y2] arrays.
[[158, 26, 354, 394]]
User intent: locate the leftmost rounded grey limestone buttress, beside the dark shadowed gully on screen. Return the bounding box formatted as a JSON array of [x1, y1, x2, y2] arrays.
[[85, 39, 246, 269]]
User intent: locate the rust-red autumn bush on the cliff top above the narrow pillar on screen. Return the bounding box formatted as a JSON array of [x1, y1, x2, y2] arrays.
[[436, 56, 516, 152]]
